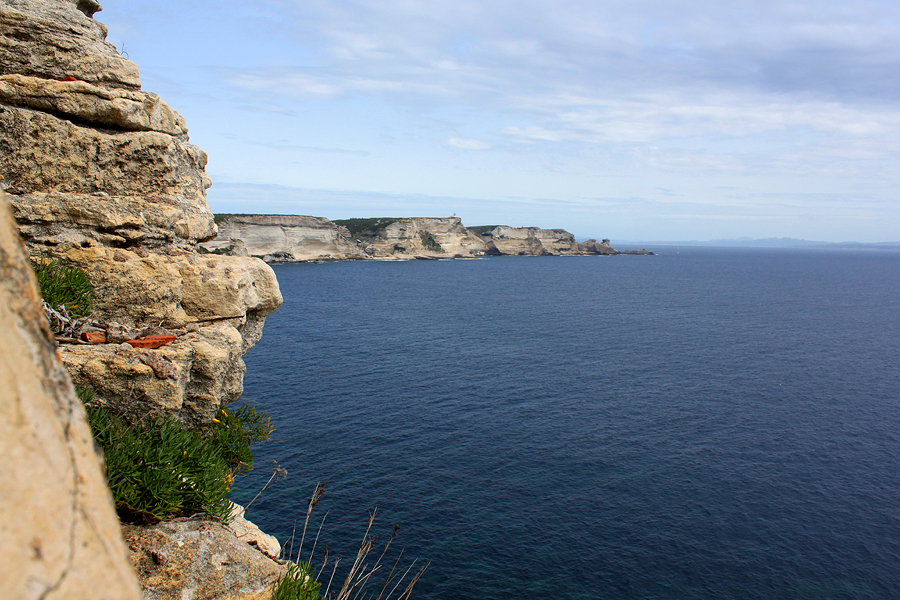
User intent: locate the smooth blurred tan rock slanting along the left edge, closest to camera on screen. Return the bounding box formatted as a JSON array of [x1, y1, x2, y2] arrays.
[[0, 192, 140, 600]]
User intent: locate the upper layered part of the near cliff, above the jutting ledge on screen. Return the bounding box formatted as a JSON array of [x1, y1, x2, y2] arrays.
[[0, 0, 216, 247]]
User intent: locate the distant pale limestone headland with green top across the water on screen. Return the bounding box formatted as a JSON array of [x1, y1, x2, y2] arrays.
[[200, 214, 653, 263]]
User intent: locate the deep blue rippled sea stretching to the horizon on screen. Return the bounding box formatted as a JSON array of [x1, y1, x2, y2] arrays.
[[234, 247, 900, 600]]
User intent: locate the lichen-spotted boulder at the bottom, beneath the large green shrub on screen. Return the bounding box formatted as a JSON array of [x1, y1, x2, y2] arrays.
[[123, 520, 286, 600]]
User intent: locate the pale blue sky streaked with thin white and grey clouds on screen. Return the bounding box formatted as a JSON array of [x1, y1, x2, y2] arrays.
[[95, 0, 900, 242]]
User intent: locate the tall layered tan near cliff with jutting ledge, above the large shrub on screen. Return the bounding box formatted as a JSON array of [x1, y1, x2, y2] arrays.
[[0, 0, 281, 423]]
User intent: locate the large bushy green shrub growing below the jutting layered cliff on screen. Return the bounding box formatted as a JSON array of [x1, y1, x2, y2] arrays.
[[79, 391, 272, 522]]
